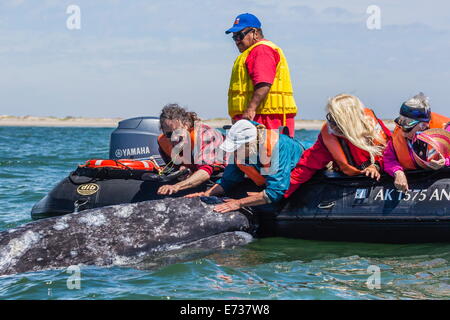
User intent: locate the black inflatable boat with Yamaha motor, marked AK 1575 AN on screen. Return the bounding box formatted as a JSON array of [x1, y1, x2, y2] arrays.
[[31, 117, 450, 243]]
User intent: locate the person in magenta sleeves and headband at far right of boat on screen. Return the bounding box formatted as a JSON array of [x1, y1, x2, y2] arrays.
[[383, 92, 450, 192]]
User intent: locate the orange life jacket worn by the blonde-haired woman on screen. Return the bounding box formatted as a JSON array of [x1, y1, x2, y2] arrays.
[[320, 108, 389, 176]]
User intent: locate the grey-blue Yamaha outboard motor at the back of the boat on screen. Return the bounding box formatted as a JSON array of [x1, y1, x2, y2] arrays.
[[109, 117, 162, 163]]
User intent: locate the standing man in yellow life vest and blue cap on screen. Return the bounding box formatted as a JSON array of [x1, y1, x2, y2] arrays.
[[225, 13, 297, 137]]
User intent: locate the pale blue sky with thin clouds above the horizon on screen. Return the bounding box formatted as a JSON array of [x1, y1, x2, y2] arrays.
[[0, 0, 450, 119]]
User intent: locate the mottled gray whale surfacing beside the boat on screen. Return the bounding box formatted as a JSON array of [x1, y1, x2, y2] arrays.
[[0, 198, 252, 275]]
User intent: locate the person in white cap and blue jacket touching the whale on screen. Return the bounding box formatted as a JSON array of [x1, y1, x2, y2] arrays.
[[186, 119, 303, 213]]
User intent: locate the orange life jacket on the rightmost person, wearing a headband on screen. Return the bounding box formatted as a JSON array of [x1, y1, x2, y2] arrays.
[[392, 112, 450, 170]]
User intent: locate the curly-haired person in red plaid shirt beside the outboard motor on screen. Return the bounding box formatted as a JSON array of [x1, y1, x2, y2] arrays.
[[158, 104, 225, 195]]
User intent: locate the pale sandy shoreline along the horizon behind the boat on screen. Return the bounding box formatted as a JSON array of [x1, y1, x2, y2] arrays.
[[0, 115, 395, 130]]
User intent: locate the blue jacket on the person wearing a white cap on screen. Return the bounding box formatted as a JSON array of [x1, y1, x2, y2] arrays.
[[217, 134, 303, 202]]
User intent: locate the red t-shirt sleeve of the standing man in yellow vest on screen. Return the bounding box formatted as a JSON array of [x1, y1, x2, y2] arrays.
[[245, 39, 280, 86]]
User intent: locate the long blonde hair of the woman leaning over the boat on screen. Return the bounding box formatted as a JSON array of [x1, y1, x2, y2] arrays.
[[326, 94, 383, 163]]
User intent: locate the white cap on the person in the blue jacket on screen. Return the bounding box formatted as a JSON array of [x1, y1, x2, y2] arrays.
[[220, 120, 257, 152]]
